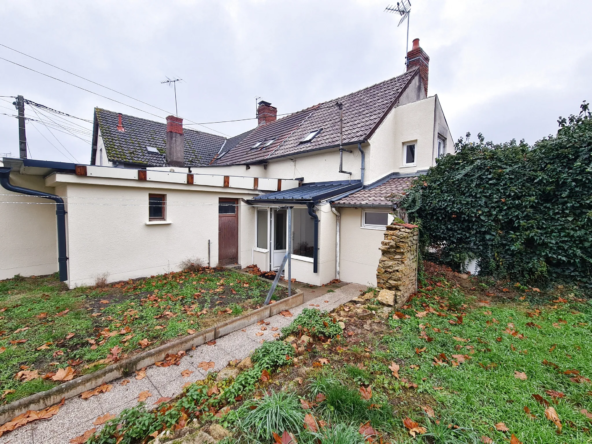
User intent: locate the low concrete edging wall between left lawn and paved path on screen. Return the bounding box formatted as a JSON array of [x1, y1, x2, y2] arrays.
[[0, 290, 304, 425]]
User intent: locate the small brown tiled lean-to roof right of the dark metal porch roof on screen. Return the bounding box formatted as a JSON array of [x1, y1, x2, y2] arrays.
[[332, 173, 417, 207]]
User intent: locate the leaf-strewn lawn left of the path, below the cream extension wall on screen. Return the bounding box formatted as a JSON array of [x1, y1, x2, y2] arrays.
[[0, 268, 287, 404]]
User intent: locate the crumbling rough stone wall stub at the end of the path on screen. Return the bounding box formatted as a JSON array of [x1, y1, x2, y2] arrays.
[[376, 224, 419, 306]]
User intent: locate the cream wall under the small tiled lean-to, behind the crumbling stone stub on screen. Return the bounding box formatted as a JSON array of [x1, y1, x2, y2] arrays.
[[338, 208, 385, 287]]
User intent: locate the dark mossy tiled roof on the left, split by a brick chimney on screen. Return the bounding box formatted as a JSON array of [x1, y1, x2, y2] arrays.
[[95, 108, 226, 167]]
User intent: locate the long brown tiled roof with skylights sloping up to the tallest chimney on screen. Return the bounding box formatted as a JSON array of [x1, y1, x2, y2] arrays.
[[215, 69, 419, 165]]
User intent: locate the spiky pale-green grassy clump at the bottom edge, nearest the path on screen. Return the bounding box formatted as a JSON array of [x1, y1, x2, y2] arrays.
[[240, 392, 304, 442]]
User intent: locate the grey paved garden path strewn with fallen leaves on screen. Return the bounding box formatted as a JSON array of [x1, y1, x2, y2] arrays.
[[0, 284, 366, 444]]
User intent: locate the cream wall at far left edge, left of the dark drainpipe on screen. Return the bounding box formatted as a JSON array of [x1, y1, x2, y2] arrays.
[[0, 173, 58, 279]]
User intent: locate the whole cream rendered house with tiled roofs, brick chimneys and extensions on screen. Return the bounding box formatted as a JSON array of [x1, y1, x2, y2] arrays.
[[0, 39, 452, 287]]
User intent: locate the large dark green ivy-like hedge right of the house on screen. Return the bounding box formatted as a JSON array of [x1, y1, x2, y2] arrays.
[[401, 103, 592, 286]]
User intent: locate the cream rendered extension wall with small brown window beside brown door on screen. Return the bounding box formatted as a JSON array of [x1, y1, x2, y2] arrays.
[[67, 183, 252, 288]]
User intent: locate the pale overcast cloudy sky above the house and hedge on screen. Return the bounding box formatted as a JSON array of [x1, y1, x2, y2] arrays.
[[0, 0, 592, 163]]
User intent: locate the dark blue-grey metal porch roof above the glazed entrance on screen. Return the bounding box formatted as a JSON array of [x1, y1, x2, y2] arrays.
[[249, 180, 362, 204]]
